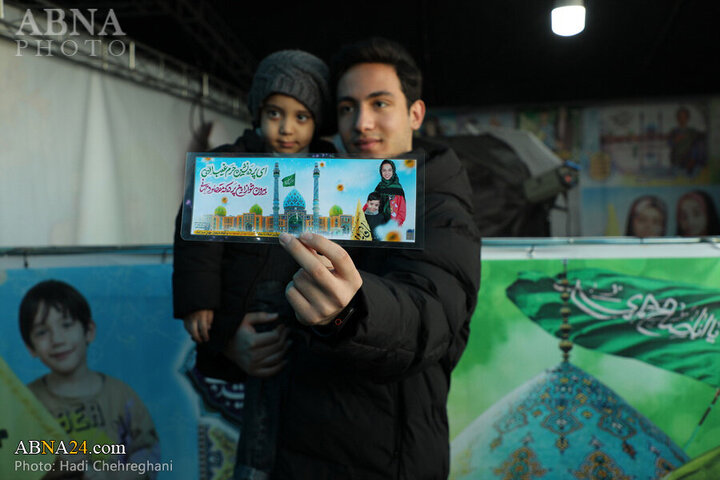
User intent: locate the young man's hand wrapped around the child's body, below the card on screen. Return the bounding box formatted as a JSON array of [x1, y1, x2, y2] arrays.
[[225, 312, 290, 377]]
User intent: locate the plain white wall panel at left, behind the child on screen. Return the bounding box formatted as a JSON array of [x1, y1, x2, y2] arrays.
[[0, 40, 247, 247]]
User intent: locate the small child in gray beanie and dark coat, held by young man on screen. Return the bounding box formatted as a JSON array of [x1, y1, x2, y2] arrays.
[[173, 50, 335, 479]]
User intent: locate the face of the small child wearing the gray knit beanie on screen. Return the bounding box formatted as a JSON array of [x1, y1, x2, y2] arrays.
[[260, 93, 315, 153]]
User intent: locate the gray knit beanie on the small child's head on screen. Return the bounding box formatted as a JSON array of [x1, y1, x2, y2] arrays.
[[248, 50, 330, 131]]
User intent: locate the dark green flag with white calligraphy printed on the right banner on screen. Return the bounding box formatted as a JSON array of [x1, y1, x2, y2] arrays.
[[506, 269, 720, 388]]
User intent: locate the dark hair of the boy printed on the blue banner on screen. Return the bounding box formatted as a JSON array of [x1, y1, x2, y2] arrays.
[[20, 280, 92, 348]]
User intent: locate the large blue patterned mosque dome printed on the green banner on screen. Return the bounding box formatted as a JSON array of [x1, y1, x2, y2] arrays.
[[450, 362, 689, 480]]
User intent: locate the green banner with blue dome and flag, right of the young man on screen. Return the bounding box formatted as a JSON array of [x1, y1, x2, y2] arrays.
[[448, 256, 720, 474]]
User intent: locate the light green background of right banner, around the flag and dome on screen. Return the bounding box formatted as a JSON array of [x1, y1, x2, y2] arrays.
[[448, 258, 720, 478]]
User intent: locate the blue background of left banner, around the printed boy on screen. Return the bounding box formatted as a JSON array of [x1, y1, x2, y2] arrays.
[[0, 265, 206, 480]]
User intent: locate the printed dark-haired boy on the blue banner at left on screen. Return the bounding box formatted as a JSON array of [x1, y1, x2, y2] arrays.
[[19, 280, 160, 478]]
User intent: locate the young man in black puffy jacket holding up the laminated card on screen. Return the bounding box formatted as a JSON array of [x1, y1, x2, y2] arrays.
[[273, 39, 480, 480]]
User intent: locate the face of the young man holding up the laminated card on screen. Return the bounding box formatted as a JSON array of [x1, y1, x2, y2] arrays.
[[337, 63, 425, 158]]
